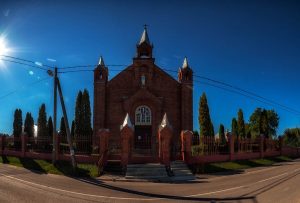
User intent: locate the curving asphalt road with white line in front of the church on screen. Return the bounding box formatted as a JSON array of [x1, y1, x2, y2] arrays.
[[0, 160, 300, 203]]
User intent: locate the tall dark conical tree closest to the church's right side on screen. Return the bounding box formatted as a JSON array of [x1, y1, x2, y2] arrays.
[[198, 93, 214, 137]]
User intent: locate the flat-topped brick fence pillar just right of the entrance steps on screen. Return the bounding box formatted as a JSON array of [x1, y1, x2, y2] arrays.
[[181, 130, 193, 163]]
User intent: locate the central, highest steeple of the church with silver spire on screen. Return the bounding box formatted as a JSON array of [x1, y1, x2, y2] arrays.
[[136, 25, 153, 59]]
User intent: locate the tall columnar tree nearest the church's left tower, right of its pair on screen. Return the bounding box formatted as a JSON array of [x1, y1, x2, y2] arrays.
[[82, 89, 92, 139]]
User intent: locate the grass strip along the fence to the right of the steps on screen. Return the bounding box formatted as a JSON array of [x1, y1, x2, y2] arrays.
[[192, 156, 292, 173]]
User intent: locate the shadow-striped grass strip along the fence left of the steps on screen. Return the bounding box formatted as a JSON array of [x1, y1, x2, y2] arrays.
[[0, 156, 98, 177]]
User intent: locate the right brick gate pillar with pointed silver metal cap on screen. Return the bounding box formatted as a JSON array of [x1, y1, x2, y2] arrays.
[[158, 113, 173, 167]]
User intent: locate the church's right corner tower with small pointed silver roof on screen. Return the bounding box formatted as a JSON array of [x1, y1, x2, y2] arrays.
[[178, 57, 193, 130]]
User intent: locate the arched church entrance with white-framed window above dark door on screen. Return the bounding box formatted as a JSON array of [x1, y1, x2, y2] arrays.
[[134, 105, 152, 150]]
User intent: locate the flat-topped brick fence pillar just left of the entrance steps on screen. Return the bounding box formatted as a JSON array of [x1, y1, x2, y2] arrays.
[[97, 129, 110, 167]]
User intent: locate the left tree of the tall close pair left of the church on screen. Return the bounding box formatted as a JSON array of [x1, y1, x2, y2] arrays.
[[75, 91, 83, 138]]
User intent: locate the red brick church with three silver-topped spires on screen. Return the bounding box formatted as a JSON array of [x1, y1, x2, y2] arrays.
[[94, 27, 193, 164]]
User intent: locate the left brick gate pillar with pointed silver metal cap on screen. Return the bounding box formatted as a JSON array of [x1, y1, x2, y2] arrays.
[[120, 113, 134, 168]]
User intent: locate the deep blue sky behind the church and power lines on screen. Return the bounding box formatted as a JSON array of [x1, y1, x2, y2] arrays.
[[0, 0, 300, 134]]
